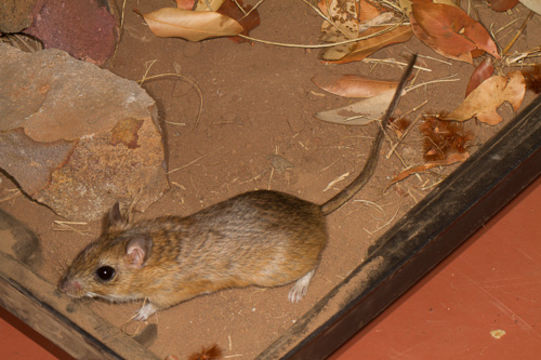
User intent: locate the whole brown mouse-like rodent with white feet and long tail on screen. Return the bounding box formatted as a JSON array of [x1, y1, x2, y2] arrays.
[[59, 55, 416, 320]]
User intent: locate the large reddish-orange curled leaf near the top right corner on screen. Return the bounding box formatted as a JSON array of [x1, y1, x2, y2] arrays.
[[410, 0, 500, 64]]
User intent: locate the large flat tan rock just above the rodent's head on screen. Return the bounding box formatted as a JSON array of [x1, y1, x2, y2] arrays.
[[0, 44, 169, 220]]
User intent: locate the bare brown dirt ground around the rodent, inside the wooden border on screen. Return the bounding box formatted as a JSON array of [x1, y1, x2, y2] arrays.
[[0, 0, 541, 359]]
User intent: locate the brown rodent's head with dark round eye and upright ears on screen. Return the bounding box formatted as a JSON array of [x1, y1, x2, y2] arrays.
[[58, 203, 152, 301]]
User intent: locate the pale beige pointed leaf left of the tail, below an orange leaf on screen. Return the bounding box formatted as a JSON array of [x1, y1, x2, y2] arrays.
[[315, 89, 395, 125]]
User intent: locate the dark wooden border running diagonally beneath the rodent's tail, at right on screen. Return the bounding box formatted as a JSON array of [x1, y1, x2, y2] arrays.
[[258, 96, 541, 360]]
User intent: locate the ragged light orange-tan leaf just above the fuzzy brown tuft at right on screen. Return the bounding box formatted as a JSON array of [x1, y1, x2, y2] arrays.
[[443, 71, 526, 125]]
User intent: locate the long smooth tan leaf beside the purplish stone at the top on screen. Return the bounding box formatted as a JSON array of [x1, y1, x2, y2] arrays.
[[143, 8, 244, 41]]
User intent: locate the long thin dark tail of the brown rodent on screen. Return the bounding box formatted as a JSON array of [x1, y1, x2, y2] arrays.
[[321, 54, 417, 215]]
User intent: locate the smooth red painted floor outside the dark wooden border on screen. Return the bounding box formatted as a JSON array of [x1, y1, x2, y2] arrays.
[[0, 174, 541, 360]]
